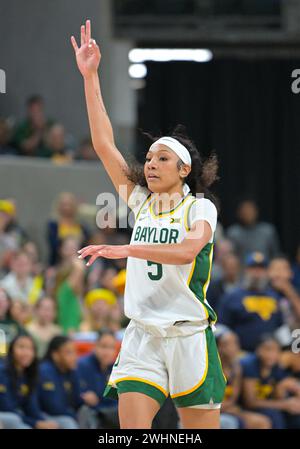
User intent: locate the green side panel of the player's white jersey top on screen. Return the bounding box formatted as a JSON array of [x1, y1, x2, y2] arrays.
[[188, 243, 217, 322]]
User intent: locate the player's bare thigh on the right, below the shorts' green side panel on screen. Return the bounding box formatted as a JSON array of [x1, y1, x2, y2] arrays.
[[177, 407, 220, 429]]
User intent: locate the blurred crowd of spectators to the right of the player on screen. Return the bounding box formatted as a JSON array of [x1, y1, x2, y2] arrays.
[[207, 200, 300, 429]]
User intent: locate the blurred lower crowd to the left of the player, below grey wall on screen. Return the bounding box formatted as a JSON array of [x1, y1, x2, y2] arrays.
[[0, 192, 129, 428]]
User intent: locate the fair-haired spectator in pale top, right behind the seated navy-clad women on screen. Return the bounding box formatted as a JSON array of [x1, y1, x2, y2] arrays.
[[26, 296, 62, 359]]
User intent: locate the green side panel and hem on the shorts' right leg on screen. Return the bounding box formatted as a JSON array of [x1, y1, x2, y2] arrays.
[[171, 326, 227, 407]]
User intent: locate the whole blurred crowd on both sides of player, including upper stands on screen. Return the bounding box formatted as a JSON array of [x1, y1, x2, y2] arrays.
[[0, 96, 300, 429]]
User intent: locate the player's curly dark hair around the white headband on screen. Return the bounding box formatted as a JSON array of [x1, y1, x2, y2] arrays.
[[126, 125, 219, 209]]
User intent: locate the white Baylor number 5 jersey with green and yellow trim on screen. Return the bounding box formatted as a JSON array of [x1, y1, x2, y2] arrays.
[[124, 185, 217, 328]]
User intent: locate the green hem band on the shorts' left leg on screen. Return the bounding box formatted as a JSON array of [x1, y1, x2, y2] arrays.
[[103, 380, 167, 406]]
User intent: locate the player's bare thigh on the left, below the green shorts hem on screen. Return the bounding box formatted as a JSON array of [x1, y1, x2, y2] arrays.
[[119, 392, 160, 429]]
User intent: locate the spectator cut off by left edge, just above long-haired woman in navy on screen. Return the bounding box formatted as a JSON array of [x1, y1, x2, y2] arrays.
[[0, 288, 24, 350]]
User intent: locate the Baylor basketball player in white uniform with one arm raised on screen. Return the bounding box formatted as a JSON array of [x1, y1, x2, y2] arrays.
[[71, 20, 226, 429]]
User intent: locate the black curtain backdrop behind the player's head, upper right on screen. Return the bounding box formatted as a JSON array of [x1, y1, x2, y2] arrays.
[[137, 59, 300, 256]]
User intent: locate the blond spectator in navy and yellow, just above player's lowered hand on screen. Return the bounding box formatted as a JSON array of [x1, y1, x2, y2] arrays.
[[47, 192, 89, 265]]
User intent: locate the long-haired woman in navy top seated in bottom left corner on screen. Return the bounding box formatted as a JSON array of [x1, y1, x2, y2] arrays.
[[0, 334, 58, 429]]
